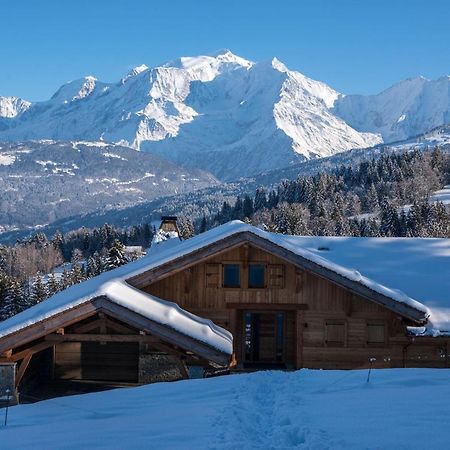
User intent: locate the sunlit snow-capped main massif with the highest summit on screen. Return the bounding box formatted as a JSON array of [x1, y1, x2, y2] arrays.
[[0, 51, 380, 180]]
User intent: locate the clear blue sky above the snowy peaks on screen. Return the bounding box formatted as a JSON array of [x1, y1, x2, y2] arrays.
[[0, 0, 450, 101]]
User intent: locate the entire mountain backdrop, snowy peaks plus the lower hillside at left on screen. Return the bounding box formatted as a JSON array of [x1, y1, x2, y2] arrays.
[[0, 50, 450, 237]]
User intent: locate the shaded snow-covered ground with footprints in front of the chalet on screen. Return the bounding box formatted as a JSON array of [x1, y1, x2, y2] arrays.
[[0, 369, 450, 450]]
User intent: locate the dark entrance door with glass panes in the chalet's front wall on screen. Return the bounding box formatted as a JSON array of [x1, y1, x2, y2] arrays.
[[244, 311, 285, 363]]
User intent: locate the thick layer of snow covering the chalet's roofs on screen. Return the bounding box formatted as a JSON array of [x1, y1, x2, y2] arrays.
[[0, 221, 450, 344]]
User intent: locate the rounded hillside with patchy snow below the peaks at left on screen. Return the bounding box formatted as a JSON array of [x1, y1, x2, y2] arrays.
[[0, 141, 218, 231]]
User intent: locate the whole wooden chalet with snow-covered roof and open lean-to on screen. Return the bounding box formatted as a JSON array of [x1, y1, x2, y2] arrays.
[[0, 221, 450, 400]]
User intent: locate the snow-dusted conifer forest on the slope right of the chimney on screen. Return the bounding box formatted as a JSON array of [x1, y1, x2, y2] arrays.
[[207, 149, 450, 237]]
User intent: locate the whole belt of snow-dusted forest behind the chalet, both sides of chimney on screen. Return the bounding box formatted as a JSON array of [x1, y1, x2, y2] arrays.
[[0, 149, 450, 320]]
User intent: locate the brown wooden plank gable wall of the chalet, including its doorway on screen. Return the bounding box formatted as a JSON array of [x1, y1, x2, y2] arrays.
[[139, 242, 448, 369]]
